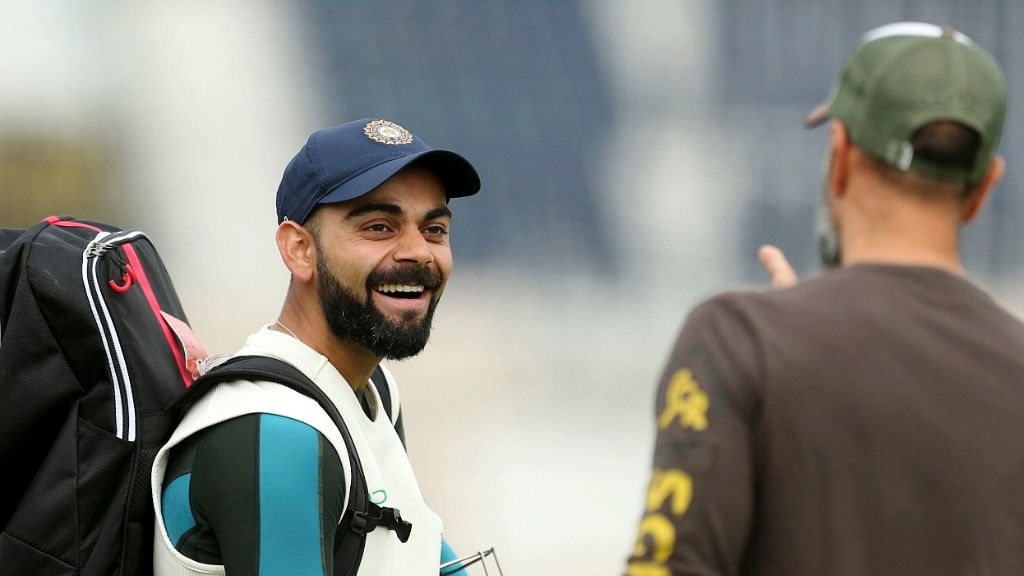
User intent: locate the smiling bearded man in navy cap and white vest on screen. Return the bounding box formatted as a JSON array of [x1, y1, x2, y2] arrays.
[[154, 120, 480, 576]]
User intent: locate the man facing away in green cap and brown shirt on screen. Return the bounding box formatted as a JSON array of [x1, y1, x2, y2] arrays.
[[627, 23, 1024, 576]]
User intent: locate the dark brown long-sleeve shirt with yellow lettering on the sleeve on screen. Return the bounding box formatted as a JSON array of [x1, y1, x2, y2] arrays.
[[627, 264, 1024, 576]]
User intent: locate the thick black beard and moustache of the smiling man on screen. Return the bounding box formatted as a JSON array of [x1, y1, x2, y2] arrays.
[[316, 251, 440, 360]]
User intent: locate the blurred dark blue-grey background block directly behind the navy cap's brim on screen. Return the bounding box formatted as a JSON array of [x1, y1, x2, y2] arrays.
[[307, 0, 613, 272]]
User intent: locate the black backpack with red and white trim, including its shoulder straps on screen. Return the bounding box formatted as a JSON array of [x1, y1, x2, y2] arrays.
[[0, 216, 410, 576]]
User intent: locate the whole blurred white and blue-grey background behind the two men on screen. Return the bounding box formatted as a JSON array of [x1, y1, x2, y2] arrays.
[[0, 0, 1024, 575]]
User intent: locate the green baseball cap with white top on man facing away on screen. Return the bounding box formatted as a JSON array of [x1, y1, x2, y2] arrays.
[[805, 23, 1007, 184]]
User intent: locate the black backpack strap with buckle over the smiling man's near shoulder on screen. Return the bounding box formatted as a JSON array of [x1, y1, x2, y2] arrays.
[[184, 356, 413, 574]]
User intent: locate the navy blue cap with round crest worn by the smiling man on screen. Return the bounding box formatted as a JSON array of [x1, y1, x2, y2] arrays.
[[278, 118, 480, 224]]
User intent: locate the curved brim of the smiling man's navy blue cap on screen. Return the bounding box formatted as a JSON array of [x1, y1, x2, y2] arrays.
[[317, 150, 480, 204]]
